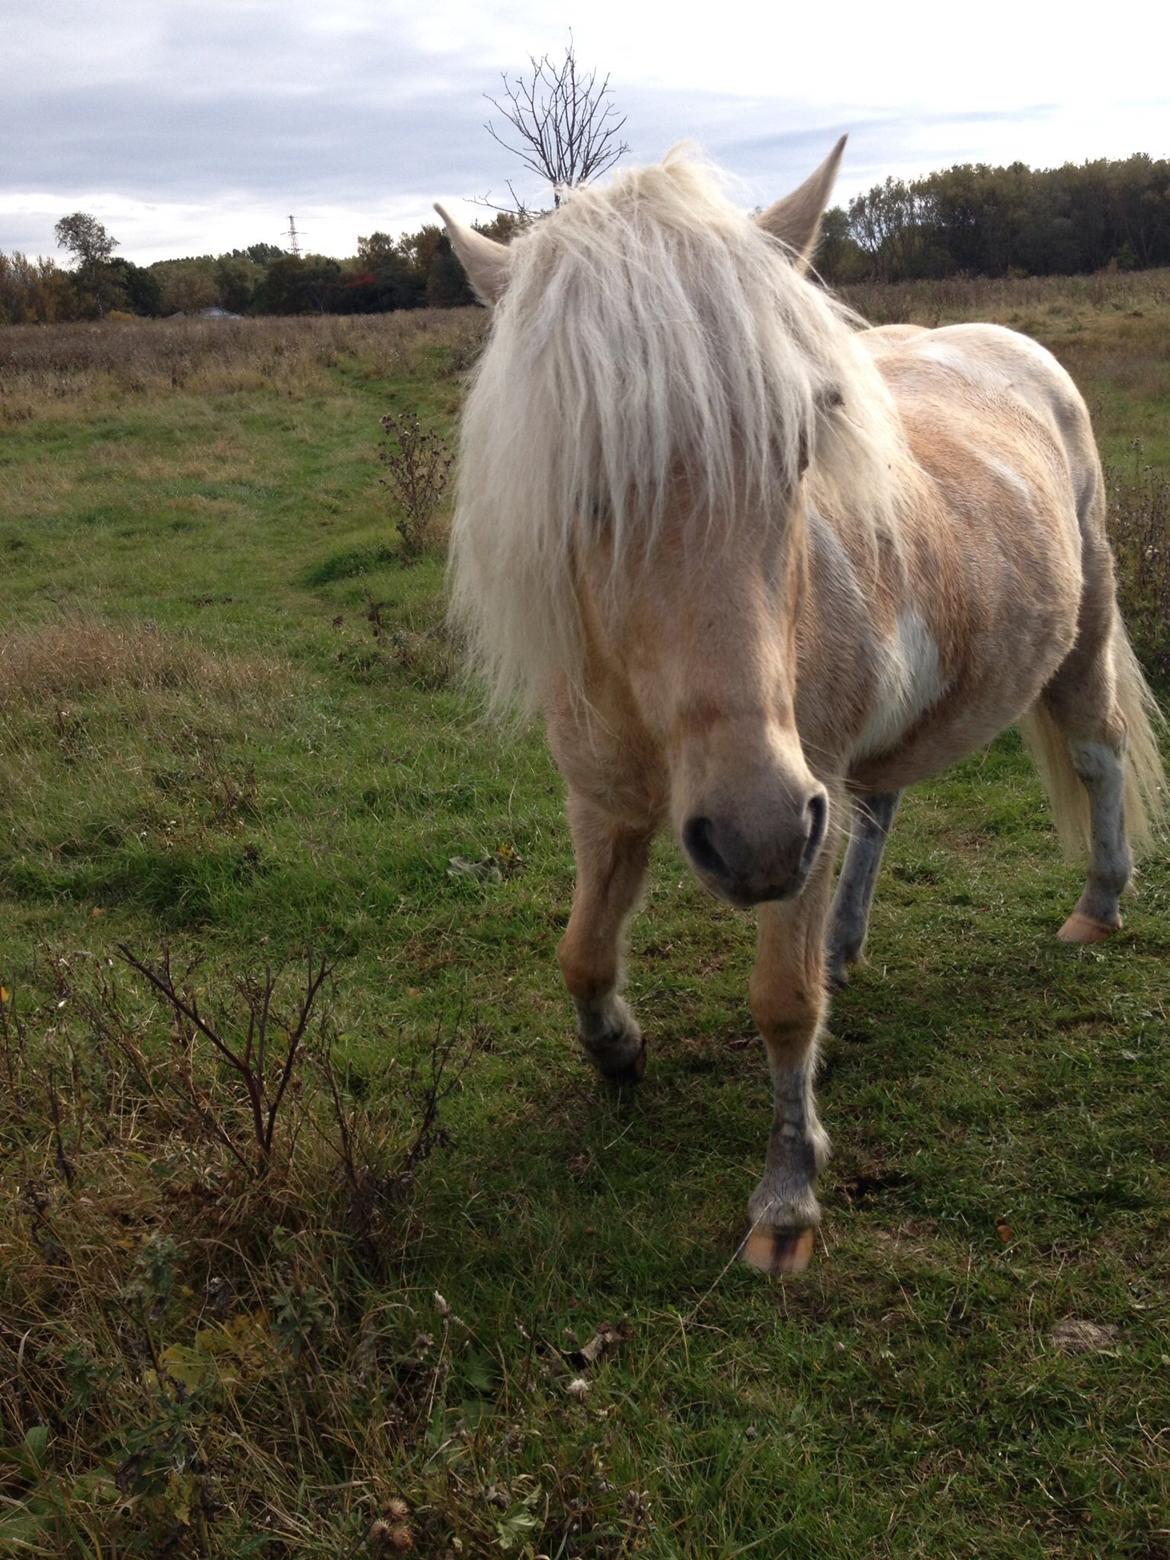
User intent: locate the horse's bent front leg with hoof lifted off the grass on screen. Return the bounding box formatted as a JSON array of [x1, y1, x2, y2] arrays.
[[557, 791, 654, 1083]]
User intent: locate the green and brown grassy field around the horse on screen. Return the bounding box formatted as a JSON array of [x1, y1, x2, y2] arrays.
[[0, 273, 1170, 1560]]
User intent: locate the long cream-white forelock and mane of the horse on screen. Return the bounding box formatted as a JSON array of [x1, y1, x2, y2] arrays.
[[451, 150, 900, 708]]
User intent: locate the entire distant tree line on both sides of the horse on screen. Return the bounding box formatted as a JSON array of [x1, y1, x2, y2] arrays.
[[0, 150, 1170, 324]]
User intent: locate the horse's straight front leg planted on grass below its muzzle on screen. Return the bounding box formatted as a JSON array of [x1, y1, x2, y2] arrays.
[[743, 852, 833, 1273]]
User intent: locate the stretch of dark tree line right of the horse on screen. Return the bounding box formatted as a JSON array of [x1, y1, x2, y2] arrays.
[[817, 153, 1170, 282]]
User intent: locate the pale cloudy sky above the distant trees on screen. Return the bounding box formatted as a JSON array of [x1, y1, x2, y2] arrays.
[[0, 0, 1170, 264]]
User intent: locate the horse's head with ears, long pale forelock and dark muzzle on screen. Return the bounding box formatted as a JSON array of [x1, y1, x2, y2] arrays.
[[443, 144, 846, 905]]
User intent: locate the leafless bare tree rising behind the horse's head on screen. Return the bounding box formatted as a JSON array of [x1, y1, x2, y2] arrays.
[[484, 34, 630, 212]]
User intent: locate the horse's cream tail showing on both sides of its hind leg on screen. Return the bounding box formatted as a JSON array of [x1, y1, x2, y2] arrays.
[[1020, 618, 1167, 860]]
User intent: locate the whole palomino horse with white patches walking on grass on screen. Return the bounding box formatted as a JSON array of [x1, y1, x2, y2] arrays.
[[440, 142, 1162, 1273]]
